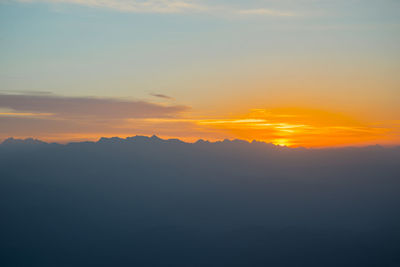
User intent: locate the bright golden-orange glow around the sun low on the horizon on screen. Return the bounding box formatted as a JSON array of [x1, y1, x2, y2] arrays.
[[194, 108, 398, 147]]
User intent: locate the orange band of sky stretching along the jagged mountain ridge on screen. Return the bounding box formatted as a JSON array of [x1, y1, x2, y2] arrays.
[[0, 105, 400, 147]]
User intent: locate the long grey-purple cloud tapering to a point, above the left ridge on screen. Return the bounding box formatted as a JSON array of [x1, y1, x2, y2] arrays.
[[0, 94, 188, 119]]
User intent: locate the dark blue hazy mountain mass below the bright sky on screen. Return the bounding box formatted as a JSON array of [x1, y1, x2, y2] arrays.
[[0, 136, 400, 267]]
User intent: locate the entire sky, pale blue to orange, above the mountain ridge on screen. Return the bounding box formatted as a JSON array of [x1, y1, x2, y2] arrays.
[[0, 0, 400, 147]]
